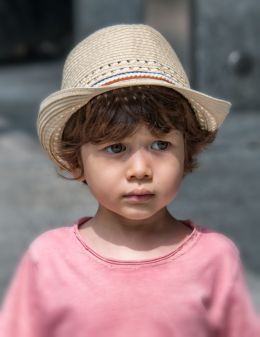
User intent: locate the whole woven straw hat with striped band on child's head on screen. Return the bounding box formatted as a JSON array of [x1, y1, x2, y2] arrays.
[[37, 24, 231, 169]]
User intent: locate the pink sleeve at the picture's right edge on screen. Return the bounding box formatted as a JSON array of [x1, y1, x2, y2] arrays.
[[223, 259, 260, 337]]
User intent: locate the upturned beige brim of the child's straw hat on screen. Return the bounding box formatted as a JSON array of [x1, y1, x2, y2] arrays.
[[37, 78, 231, 169]]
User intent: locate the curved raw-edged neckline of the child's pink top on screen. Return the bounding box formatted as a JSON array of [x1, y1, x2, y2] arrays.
[[73, 217, 200, 267]]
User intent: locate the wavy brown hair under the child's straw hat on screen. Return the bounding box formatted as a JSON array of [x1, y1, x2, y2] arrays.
[[59, 86, 216, 178]]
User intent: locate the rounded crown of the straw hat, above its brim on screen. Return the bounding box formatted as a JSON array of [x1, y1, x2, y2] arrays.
[[62, 24, 190, 89]]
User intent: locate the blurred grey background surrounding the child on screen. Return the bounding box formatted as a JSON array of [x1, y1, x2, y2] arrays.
[[0, 0, 260, 309]]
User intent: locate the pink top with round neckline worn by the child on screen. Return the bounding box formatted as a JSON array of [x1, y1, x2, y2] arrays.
[[0, 217, 260, 337]]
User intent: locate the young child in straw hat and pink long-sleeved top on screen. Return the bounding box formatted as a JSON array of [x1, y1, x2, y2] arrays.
[[1, 25, 260, 337]]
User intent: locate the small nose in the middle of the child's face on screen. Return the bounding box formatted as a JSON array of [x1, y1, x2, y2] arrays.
[[126, 150, 153, 180]]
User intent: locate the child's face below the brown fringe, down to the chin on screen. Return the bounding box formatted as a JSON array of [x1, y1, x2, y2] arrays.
[[81, 126, 184, 220]]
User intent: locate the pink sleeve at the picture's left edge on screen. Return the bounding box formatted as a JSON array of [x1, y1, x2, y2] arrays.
[[0, 250, 44, 337]]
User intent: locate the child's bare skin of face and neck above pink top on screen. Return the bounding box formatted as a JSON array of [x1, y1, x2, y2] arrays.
[[74, 125, 191, 260]]
